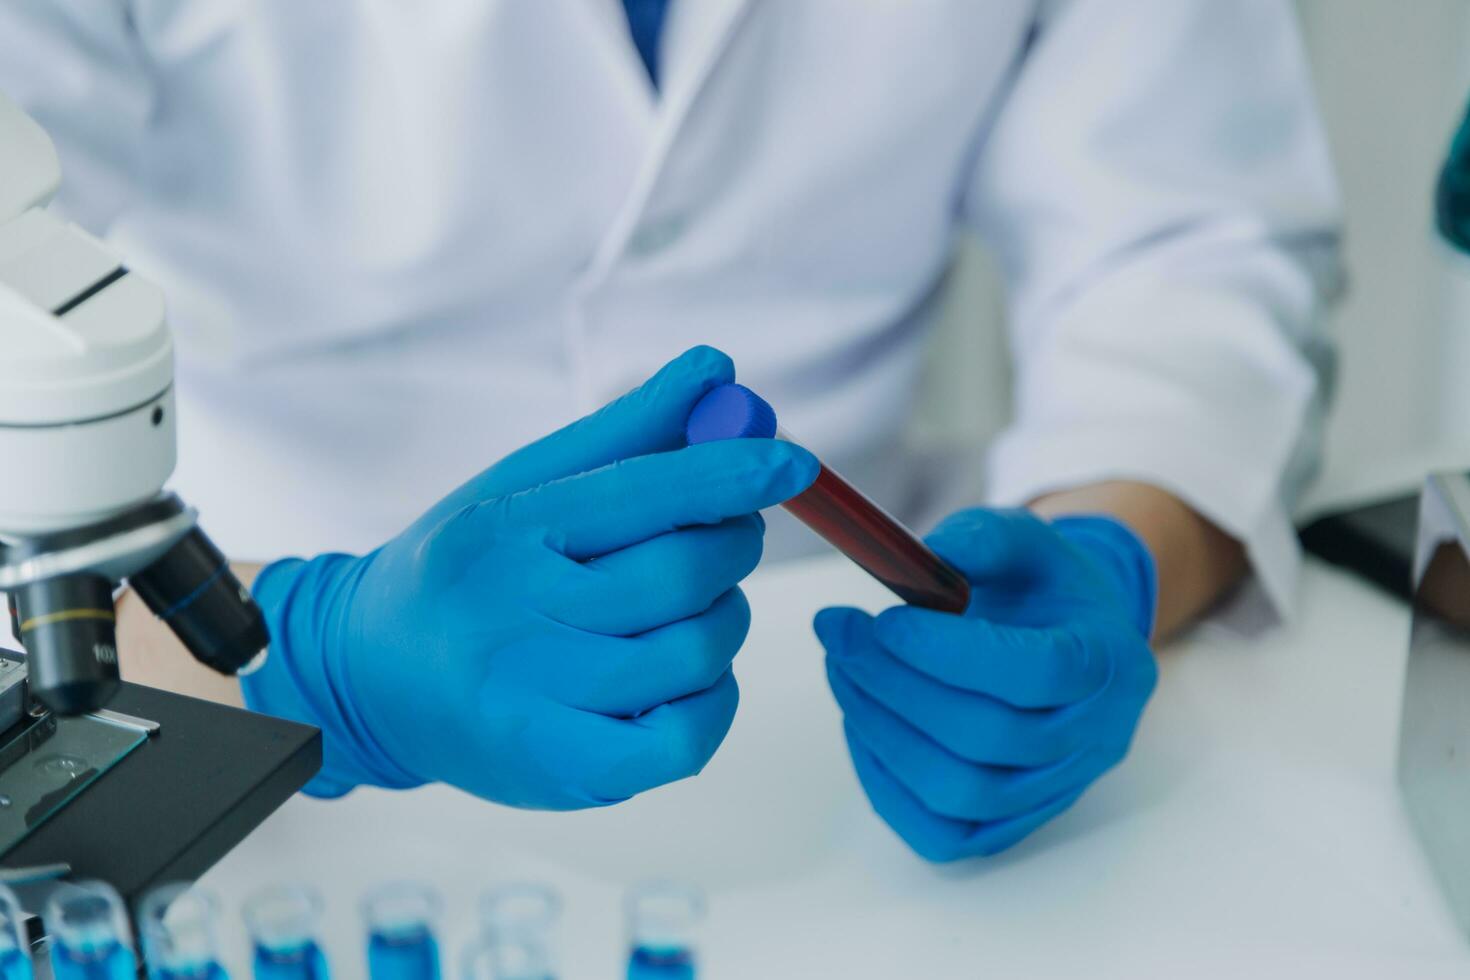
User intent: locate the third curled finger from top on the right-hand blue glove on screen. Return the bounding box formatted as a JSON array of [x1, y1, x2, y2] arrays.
[[828, 670, 1122, 821]]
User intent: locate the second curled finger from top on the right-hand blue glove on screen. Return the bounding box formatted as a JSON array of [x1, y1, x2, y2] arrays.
[[816, 608, 1089, 767]]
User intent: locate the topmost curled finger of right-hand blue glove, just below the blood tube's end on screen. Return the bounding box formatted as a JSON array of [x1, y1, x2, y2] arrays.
[[873, 605, 1111, 708]]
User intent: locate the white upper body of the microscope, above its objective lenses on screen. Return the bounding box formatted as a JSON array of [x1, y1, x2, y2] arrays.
[[0, 96, 175, 538]]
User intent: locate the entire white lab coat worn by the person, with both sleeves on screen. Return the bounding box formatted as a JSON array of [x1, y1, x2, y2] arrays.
[[0, 0, 1338, 617]]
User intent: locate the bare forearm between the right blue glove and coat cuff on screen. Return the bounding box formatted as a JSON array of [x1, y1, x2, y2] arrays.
[[1032, 480, 1247, 641]]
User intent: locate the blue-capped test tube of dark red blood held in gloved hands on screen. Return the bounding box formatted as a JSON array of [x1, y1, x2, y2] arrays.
[[686, 383, 970, 613]]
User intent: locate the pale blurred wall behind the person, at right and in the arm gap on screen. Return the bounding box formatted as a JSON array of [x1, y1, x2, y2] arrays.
[[919, 0, 1470, 517]]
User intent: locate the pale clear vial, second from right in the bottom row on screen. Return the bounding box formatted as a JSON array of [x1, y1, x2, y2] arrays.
[[463, 883, 562, 980]]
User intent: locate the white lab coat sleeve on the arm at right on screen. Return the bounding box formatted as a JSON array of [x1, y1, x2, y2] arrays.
[[963, 0, 1339, 616]]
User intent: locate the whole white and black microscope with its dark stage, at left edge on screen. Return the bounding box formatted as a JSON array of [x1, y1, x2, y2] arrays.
[[0, 96, 320, 896]]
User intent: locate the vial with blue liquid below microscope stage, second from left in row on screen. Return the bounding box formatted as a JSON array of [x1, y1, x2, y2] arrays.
[[43, 882, 138, 980]]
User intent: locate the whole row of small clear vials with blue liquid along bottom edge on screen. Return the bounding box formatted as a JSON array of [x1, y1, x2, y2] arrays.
[[0, 882, 704, 980]]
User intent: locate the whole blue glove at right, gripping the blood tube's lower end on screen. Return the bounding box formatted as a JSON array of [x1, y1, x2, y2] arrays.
[[816, 510, 1157, 861]]
